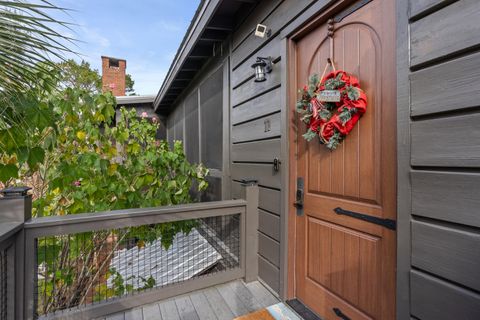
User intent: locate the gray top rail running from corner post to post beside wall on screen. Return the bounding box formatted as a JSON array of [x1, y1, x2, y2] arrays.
[[24, 200, 247, 236]]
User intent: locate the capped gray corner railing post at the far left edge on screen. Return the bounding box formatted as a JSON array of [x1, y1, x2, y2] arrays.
[[0, 187, 33, 319]]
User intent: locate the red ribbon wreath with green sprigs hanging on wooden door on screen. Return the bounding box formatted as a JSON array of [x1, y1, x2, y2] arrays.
[[297, 70, 367, 150]]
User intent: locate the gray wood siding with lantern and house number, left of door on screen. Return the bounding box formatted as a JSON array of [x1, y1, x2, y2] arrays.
[[230, 0, 316, 292]]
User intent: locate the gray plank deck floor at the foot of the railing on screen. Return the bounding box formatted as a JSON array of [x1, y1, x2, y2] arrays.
[[104, 280, 279, 320]]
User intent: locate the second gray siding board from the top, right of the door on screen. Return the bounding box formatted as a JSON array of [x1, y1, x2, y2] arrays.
[[410, 0, 480, 67]]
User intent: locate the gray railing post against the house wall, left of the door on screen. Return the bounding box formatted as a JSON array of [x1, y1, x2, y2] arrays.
[[242, 180, 258, 282]]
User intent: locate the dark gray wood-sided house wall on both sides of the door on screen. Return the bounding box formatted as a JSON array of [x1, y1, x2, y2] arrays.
[[159, 0, 480, 319]]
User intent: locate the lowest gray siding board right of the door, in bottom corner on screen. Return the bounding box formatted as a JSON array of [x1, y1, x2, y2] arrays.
[[410, 271, 480, 320]]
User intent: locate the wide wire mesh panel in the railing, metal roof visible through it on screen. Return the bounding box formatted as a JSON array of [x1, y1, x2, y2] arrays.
[[34, 214, 240, 316]]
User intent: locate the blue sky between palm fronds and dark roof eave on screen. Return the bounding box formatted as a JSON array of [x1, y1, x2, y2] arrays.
[[53, 0, 199, 94]]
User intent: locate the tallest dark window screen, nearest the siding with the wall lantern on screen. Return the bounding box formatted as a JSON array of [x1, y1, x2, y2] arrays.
[[200, 68, 223, 170]]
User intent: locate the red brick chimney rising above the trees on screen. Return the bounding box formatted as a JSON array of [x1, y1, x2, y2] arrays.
[[102, 56, 127, 97]]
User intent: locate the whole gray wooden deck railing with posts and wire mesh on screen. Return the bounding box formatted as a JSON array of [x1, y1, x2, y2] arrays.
[[0, 185, 258, 320]]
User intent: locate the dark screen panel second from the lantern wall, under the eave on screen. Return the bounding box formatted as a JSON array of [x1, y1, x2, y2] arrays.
[[185, 90, 200, 163]]
